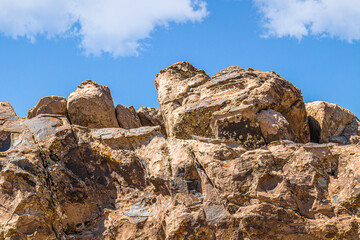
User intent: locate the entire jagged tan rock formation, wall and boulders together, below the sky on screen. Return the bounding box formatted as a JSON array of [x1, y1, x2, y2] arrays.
[[0, 62, 360, 240]]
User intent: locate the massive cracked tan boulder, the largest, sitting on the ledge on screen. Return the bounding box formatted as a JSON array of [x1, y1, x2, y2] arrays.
[[155, 62, 310, 149]]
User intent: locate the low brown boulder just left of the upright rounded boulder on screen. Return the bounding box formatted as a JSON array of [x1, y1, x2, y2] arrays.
[[27, 96, 67, 119]]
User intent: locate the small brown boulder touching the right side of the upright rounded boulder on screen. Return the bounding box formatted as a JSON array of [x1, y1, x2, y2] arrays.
[[116, 104, 141, 129]]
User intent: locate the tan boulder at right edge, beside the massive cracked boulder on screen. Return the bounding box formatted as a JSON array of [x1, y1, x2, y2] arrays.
[[306, 101, 360, 144]]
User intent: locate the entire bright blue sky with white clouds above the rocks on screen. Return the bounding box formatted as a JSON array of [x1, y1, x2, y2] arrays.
[[0, 0, 360, 116]]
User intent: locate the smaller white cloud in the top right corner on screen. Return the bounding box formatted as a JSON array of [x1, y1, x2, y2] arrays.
[[253, 0, 360, 42]]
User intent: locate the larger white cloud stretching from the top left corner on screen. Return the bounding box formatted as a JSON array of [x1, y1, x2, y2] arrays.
[[0, 0, 208, 57]]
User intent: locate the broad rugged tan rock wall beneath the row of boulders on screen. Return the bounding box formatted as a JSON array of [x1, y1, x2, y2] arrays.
[[0, 106, 360, 240]]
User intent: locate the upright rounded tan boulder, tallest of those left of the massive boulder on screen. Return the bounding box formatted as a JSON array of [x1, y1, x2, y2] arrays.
[[67, 80, 119, 128]]
